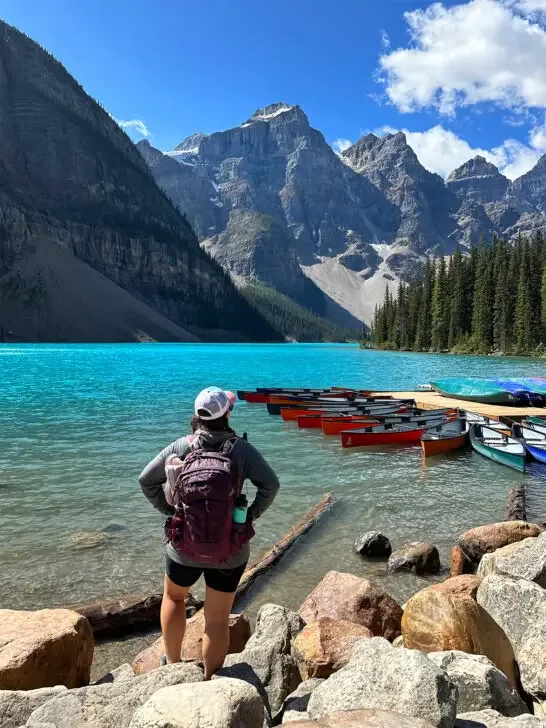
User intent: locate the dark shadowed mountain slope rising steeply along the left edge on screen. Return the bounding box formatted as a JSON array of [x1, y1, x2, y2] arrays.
[[0, 22, 279, 341]]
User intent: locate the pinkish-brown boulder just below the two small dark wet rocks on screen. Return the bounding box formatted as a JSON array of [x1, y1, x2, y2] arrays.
[[299, 571, 402, 640]]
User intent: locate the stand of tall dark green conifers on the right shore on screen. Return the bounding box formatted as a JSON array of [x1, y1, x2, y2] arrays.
[[372, 233, 546, 355]]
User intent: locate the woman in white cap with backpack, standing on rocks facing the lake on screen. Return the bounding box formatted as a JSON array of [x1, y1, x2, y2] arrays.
[[139, 387, 279, 680]]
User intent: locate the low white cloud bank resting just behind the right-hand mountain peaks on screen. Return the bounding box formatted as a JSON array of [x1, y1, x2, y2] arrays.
[[377, 125, 546, 179]]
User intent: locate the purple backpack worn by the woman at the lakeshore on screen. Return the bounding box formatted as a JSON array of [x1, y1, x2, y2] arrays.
[[165, 437, 254, 564]]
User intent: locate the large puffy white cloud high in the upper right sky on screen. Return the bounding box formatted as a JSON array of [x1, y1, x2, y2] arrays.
[[380, 0, 546, 116]]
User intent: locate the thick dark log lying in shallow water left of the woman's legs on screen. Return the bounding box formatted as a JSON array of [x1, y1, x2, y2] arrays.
[[72, 594, 203, 637]]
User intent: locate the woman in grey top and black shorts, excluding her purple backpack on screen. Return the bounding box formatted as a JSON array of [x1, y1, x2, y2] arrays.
[[139, 388, 279, 680]]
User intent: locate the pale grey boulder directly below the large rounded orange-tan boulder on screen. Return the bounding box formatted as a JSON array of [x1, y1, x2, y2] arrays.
[[428, 650, 528, 717]]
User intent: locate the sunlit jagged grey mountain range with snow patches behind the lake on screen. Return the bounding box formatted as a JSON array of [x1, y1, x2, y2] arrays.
[[137, 103, 546, 323]]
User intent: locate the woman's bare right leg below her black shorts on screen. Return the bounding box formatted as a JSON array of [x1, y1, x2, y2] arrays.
[[203, 584, 235, 680]]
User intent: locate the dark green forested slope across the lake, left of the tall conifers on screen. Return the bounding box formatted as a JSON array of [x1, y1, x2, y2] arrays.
[[240, 282, 361, 342]]
